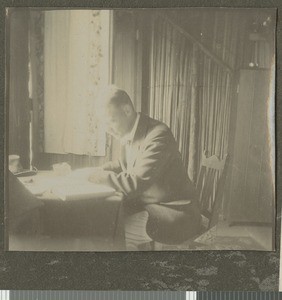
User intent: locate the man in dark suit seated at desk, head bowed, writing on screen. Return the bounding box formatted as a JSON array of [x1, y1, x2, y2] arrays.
[[89, 86, 200, 250]]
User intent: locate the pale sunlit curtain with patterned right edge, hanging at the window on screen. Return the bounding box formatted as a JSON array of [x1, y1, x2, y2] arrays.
[[44, 10, 110, 156]]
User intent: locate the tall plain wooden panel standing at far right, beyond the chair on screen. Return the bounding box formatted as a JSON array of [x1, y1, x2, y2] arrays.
[[228, 70, 273, 223]]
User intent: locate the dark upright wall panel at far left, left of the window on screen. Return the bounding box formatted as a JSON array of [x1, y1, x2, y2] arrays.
[[7, 10, 29, 168]]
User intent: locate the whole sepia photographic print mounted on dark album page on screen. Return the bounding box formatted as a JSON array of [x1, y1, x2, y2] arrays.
[[5, 8, 276, 251]]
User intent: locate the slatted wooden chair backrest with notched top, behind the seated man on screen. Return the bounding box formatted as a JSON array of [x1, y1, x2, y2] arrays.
[[197, 151, 228, 229]]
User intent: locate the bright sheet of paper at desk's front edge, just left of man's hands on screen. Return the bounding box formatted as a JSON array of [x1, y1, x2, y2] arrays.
[[51, 182, 115, 201]]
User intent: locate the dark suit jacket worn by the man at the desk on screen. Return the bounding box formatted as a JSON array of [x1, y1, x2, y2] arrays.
[[100, 114, 201, 244]]
